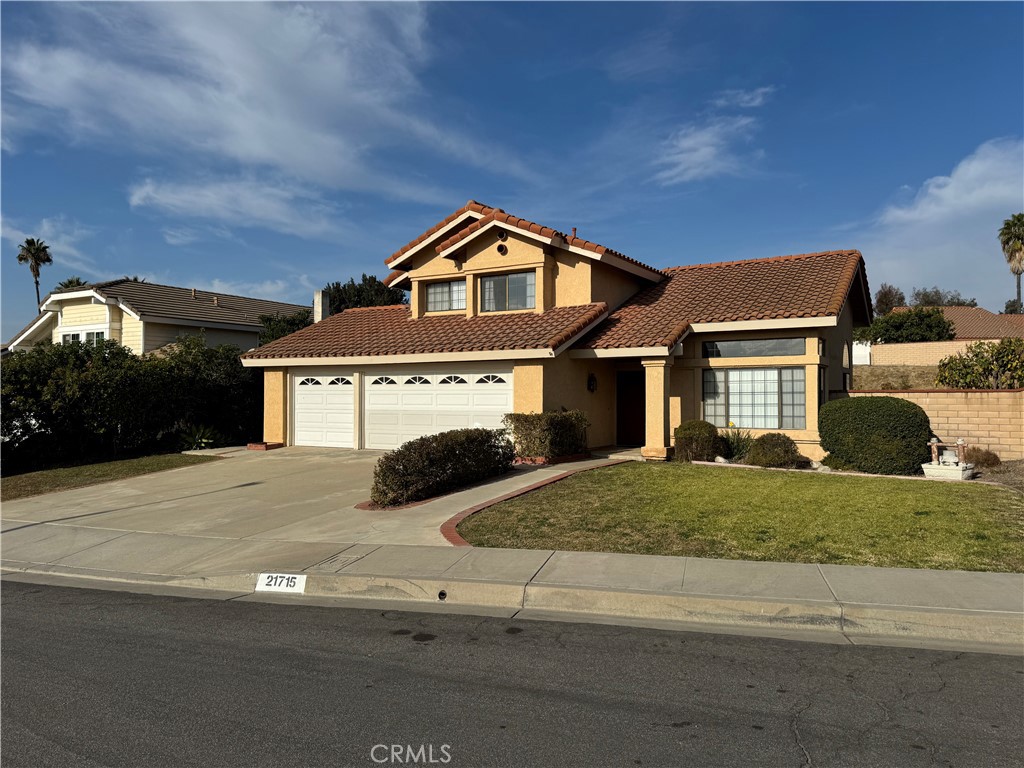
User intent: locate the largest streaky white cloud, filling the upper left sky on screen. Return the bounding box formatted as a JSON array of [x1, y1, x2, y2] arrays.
[[3, 3, 530, 207]]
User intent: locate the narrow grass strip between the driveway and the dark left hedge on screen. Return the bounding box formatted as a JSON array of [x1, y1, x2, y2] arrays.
[[0, 454, 219, 502]]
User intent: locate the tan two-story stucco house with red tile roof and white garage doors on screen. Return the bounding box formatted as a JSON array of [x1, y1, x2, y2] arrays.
[[243, 201, 871, 459]]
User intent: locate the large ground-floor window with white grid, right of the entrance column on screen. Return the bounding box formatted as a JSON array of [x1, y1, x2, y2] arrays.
[[702, 368, 807, 429]]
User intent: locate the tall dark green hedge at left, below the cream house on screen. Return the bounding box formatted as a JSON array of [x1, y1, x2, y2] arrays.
[[0, 336, 263, 474]]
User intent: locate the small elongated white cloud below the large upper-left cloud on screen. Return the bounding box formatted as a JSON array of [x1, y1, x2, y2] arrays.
[[128, 178, 345, 245]]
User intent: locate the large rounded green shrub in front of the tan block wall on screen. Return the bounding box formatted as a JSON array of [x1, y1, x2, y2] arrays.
[[818, 397, 932, 475]]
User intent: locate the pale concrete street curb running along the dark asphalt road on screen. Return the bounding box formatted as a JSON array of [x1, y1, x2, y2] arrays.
[[6, 565, 1024, 655]]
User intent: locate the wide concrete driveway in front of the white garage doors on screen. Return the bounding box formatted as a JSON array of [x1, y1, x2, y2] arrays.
[[3, 447, 468, 546]]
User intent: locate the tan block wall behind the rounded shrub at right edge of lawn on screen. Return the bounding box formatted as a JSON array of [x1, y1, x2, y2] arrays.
[[850, 393, 1024, 461]]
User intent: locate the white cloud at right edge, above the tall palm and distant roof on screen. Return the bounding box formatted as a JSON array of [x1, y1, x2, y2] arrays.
[[850, 139, 1024, 311]]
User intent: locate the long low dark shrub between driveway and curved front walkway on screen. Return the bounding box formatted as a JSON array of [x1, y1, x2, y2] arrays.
[[370, 429, 515, 507]]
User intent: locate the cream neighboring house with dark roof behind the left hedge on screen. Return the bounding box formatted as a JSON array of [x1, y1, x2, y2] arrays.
[[7, 280, 309, 354]]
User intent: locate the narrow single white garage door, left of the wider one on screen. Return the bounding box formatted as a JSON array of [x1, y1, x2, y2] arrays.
[[294, 375, 355, 447]]
